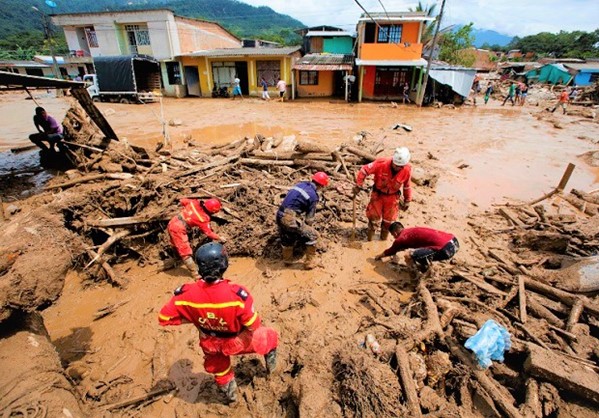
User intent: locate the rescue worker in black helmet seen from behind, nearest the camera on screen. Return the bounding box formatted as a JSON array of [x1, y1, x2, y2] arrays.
[[158, 242, 279, 402]]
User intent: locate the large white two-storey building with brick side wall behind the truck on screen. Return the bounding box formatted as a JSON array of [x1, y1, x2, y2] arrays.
[[52, 9, 241, 96]]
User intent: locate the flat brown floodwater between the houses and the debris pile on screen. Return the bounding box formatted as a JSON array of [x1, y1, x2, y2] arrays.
[[0, 92, 599, 207]]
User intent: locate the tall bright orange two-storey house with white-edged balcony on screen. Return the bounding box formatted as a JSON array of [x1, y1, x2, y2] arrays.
[[356, 12, 434, 101]]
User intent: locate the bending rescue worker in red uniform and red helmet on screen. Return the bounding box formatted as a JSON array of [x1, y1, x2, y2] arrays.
[[167, 198, 224, 279]]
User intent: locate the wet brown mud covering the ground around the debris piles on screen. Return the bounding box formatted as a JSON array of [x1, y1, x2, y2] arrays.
[[0, 89, 599, 417]]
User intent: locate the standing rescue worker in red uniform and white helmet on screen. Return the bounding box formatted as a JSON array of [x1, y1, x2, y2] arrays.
[[354, 147, 412, 241]]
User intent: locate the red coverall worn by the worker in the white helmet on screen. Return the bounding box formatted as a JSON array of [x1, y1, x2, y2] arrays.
[[356, 157, 412, 229]]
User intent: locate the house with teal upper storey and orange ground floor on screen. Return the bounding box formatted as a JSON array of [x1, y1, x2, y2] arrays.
[[293, 26, 355, 100]]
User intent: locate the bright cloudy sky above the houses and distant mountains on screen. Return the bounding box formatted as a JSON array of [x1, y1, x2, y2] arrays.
[[241, 0, 599, 37]]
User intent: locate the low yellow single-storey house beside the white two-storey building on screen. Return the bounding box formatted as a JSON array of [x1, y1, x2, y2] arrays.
[[177, 46, 301, 97]]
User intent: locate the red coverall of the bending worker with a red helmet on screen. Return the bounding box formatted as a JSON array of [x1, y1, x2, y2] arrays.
[[167, 199, 220, 259]]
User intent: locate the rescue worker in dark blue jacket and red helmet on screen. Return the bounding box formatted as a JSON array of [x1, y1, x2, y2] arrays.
[[276, 171, 329, 270]]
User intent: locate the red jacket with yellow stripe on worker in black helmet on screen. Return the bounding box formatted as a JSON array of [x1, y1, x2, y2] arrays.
[[158, 279, 261, 338]]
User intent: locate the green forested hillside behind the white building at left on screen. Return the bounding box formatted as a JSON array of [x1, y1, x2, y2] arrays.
[[0, 0, 305, 43]]
